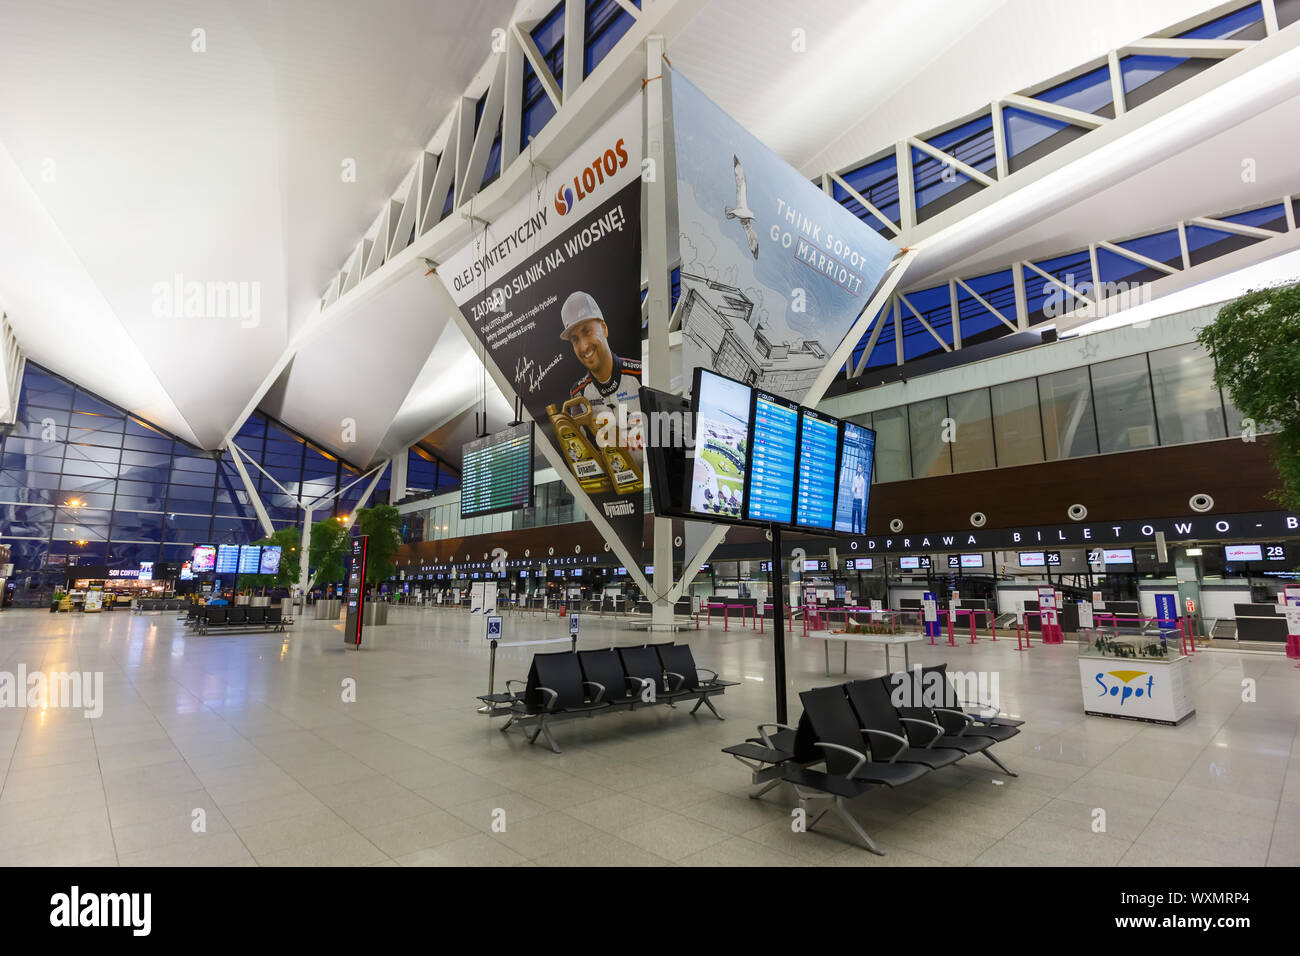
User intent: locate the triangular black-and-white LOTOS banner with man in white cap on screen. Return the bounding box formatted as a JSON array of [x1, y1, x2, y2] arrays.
[[438, 96, 645, 555]]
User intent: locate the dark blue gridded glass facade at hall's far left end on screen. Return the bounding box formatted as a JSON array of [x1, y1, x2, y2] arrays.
[[0, 362, 400, 604]]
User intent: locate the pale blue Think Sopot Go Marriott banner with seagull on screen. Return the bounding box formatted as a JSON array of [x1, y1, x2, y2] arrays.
[[672, 72, 898, 399]]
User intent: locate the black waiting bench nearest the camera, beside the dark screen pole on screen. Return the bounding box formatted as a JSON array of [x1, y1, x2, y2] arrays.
[[723, 665, 1024, 856]]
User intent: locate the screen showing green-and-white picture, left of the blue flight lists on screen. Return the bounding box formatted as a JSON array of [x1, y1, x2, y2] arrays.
[[688, 368, 751, 520]]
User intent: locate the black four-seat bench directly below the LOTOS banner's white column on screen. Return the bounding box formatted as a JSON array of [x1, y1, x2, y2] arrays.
[[478, 643, 737, 753]]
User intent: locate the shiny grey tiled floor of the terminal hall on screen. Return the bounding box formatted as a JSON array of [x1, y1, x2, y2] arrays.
[[0, 609, 1300, 866]]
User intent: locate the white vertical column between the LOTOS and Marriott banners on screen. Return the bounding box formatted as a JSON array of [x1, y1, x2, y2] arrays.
[[642, 33, 676, 630]]
